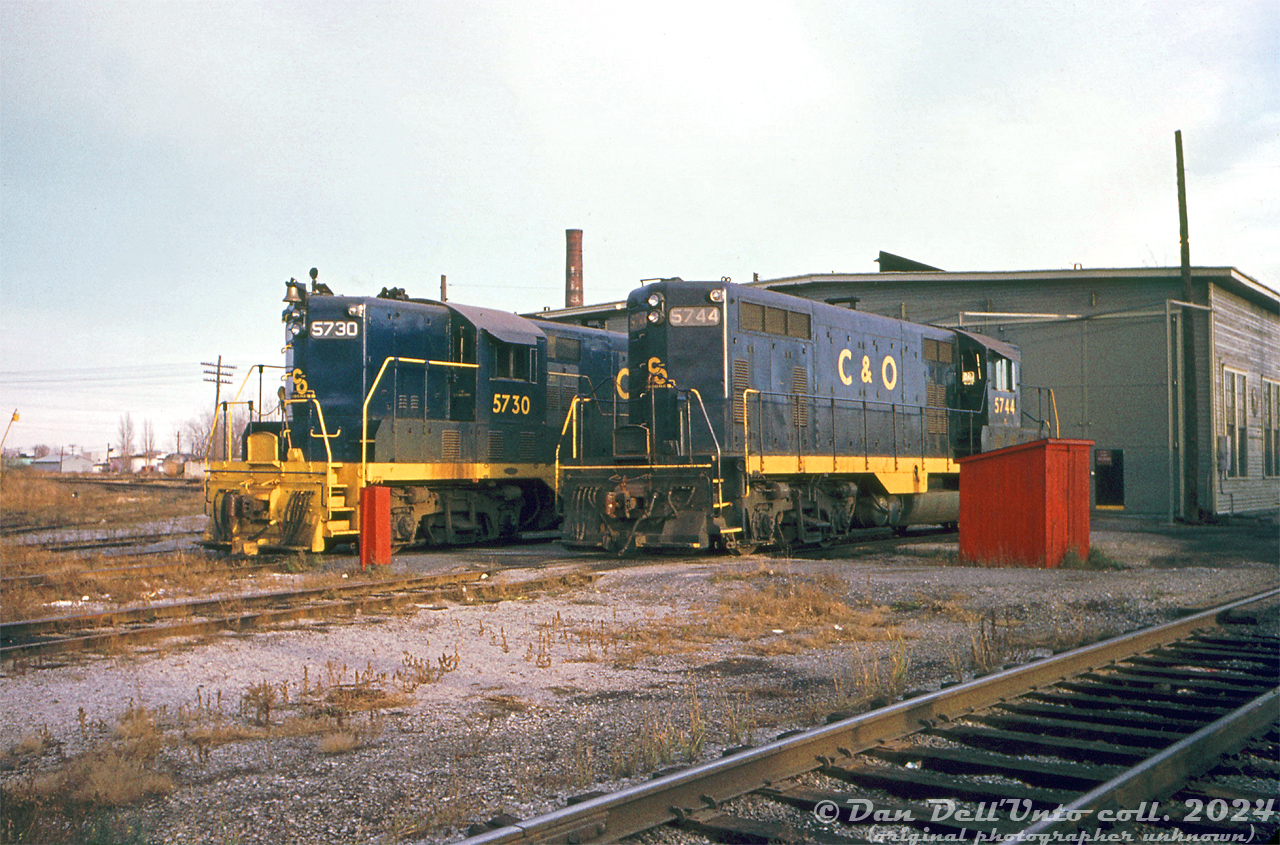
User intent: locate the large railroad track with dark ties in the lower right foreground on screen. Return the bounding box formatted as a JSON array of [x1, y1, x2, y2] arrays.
[[465, 590, 1280, 845]]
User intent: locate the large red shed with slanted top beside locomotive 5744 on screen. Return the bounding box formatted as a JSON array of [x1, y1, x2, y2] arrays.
[[960, 439, 1093, 567]]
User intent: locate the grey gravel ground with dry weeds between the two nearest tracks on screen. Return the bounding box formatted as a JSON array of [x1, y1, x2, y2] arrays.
[[0, 519, 1280, 844]]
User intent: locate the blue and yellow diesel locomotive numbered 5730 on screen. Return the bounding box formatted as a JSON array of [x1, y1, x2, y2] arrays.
[[205, 270, 626, 554]]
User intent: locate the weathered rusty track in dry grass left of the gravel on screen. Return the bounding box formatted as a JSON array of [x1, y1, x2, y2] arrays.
[[0, 570, 595, 661]]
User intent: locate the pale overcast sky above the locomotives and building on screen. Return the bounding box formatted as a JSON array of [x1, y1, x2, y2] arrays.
[[0, 0, 1280, 452]]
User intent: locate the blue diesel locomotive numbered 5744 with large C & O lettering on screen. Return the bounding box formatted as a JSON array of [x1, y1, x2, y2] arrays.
[[561, 279, 1037, 552]]
